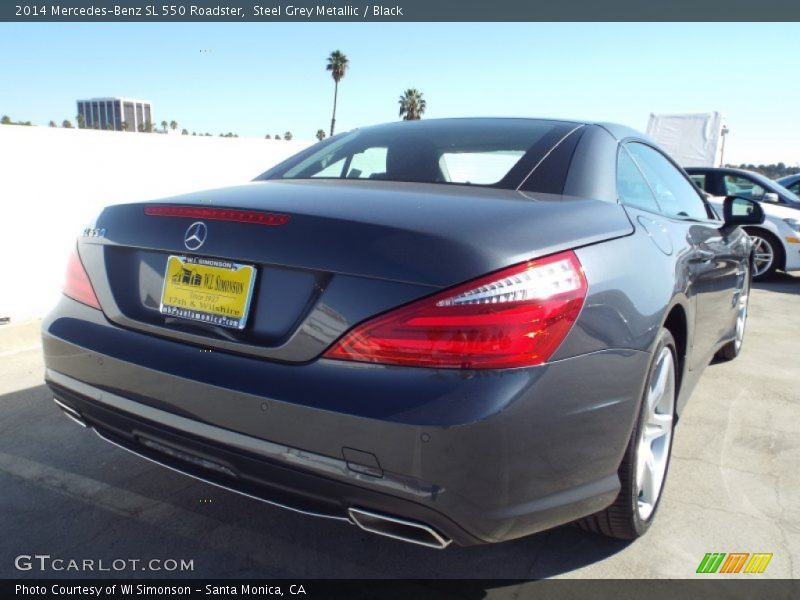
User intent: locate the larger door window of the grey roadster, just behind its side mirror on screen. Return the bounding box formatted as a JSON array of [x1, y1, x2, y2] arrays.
[[625, 143, 709, 220]]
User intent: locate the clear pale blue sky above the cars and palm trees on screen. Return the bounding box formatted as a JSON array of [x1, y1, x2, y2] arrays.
[[0, 23, 800, 164]]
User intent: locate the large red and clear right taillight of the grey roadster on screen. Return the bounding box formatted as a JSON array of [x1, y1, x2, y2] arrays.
[[325, 251, 587, 369]]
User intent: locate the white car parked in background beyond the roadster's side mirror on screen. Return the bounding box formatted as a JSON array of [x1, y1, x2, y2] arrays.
[[685, 167, 800, 279]]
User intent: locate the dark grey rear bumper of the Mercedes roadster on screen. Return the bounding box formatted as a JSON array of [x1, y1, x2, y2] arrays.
[[43, 299, 649, 545]]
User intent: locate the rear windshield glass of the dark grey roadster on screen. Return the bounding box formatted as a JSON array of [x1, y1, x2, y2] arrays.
[[258, 119, 576, 189]]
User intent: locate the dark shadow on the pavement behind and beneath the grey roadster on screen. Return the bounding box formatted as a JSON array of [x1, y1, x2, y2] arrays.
[[0, 386, 627, 584]]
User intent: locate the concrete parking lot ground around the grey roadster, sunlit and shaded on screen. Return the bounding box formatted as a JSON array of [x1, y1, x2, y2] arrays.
[[0, 276, 800, 584]]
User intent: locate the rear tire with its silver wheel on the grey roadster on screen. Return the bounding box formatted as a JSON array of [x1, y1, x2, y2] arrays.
[[578, 328, 678, 540]]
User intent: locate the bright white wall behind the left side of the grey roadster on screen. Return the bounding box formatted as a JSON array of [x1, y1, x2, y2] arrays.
[[0, 125, 310, 321]]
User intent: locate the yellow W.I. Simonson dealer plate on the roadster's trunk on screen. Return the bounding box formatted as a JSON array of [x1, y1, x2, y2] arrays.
[[161, 256, 256, 329]]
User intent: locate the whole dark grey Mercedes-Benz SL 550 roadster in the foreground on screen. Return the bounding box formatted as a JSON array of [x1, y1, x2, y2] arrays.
[[43, 119, 763, 548]]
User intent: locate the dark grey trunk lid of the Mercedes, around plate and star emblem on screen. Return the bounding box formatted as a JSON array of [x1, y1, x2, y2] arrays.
[[80, 180, 632, 362]]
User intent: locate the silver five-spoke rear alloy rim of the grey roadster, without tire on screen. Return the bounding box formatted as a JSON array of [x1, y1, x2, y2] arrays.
[[636, 347, 675, 521]]
